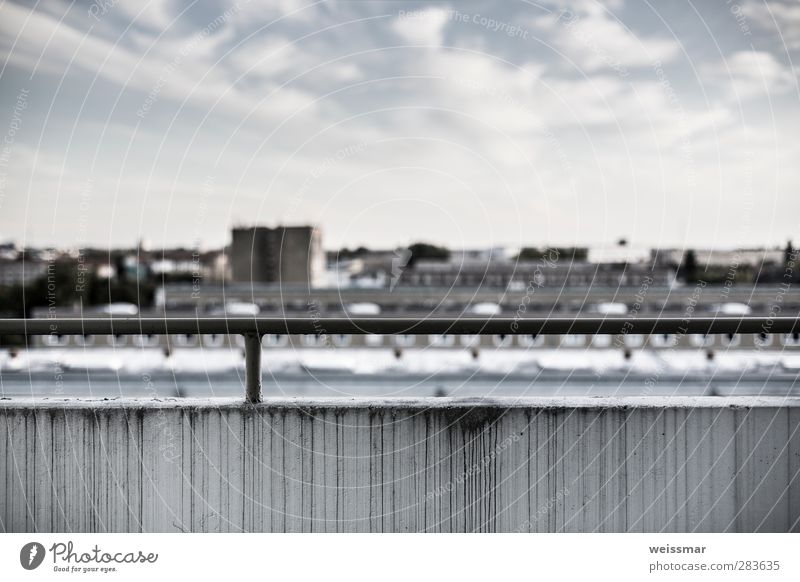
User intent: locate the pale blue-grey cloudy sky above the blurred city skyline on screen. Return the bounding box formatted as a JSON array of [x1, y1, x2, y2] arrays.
[[0, 0, 800, 248]]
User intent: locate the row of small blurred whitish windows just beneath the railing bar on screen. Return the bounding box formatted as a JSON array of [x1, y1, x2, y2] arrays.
[[43, 333, 800, 348]]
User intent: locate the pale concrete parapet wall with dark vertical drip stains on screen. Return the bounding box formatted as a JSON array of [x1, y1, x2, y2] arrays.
[[0, 398, 800, 532]]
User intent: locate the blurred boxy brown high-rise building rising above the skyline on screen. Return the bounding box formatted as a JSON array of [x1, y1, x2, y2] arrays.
[[230, 226, 325, 287]]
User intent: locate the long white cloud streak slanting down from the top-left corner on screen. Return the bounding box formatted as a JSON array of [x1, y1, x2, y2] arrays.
[[0, 5, 313, 120]]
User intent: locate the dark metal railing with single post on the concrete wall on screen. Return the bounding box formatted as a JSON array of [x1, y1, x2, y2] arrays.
[[0, 316, 800, 403]]
